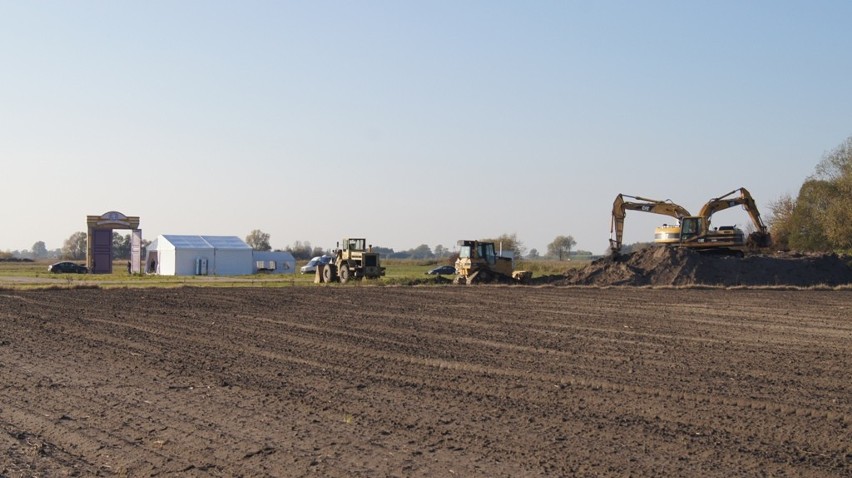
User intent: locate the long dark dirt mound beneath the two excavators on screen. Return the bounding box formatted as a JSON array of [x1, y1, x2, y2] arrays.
[[544, 247, 852, 287]]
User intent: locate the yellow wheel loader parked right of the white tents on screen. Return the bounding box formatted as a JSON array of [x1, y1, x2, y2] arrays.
[[315, 238, 385, 284]]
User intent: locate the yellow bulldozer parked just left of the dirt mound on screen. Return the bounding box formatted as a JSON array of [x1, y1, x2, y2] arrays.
[[455, 240, 532, 284]]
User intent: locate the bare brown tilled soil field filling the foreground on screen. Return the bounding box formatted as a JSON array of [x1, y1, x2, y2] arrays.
[[0, 286, 852, 477]]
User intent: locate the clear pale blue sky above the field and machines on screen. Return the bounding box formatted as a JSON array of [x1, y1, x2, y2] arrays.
[[0, 0, 852, 253]]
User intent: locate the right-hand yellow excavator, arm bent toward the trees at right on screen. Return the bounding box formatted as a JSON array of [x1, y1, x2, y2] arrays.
[[674, 188, 772, 255]]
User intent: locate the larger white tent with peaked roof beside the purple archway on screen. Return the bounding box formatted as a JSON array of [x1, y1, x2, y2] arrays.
[[145, 234, 255, 276]]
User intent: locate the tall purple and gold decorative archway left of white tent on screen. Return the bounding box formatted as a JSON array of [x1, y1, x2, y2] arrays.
[[86, 211, 142, 274]]
